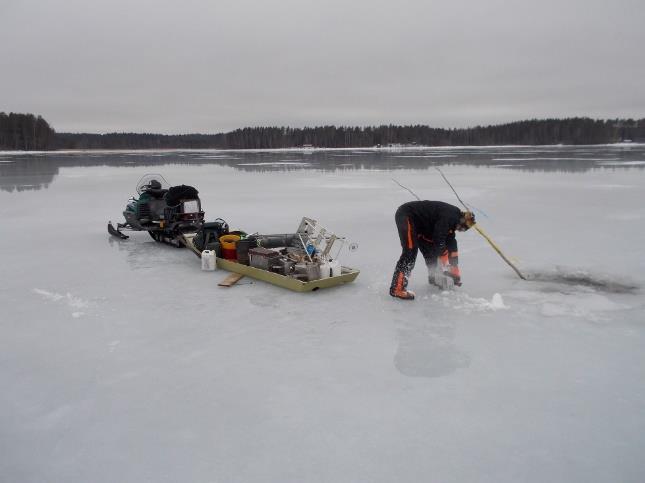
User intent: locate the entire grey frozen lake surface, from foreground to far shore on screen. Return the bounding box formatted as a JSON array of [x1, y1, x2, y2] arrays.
[[0, 145, 645, 483]]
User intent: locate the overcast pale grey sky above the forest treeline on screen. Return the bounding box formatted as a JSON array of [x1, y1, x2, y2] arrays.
[[0, 0, 645, 133]]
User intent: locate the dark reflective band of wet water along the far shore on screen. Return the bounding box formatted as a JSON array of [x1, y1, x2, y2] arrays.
[[0, 144, 645, 192]]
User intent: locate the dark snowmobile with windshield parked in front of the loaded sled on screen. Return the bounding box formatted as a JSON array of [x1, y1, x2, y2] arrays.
[[108, 174, 204, 247]]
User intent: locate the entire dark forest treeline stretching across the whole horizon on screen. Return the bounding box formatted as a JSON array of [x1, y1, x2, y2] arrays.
[[0, 112, 645, 150]]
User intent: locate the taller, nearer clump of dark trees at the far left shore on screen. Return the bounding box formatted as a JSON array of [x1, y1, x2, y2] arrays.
[[0, 112, 57, 151]]
